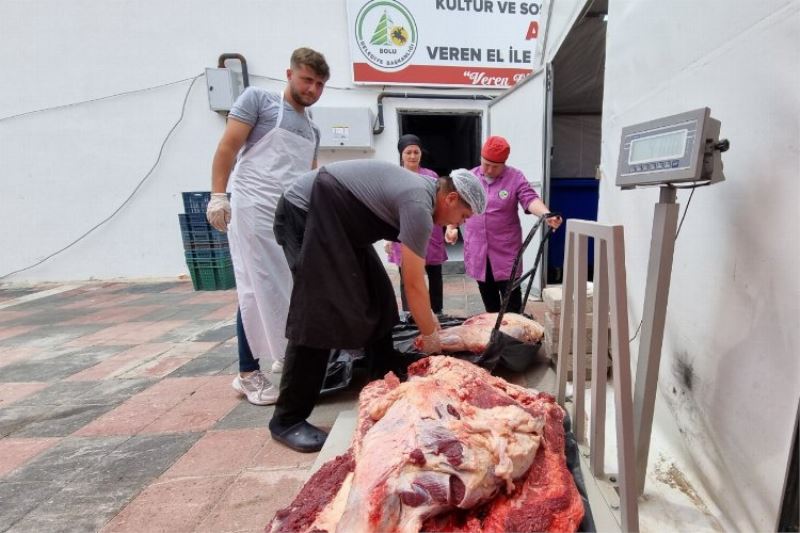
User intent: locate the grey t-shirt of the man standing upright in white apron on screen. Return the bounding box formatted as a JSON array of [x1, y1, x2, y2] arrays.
[[228, 87, 319, 159]]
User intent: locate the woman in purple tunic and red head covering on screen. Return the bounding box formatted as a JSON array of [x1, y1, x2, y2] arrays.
[[445, 135, 561, 313]]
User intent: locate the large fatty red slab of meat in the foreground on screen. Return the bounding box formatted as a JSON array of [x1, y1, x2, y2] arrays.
[[267, 356, 583, 533]]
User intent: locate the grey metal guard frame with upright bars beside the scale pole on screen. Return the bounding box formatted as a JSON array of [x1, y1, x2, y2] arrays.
[[556, 219, 639, 532]]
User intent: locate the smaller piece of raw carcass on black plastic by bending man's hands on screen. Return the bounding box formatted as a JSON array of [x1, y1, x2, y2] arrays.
[[439, 313, 544, 354]]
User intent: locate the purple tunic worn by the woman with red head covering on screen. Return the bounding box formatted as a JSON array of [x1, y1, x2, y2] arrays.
[[464, 165, 539, 281]]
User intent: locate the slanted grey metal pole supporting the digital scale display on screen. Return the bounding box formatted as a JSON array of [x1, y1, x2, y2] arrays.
[[633, 186, 678, 495]]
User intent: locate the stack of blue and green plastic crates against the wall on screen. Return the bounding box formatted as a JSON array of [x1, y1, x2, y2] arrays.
[[178, 192, 236, 291]]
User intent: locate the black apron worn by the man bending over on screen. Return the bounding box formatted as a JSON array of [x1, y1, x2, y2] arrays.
[[286, 168, 399, 348]]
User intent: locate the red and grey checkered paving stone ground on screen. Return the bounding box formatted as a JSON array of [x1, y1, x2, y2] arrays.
[[0, 272, 548, 533]]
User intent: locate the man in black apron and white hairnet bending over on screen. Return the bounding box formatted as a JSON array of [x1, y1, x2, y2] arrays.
[[269, 160, 486, 452]]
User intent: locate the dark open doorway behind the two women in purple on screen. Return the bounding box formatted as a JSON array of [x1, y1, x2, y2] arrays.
[[397, 109, 482, 274]]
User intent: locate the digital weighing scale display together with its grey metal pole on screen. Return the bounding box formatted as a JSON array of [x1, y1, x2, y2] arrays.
[[617, 107, 730, 495]]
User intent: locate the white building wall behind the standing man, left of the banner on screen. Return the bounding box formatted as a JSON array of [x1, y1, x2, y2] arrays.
[[0, 0, 510, 282]]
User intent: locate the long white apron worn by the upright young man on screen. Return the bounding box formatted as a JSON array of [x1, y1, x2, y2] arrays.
[[228, 93, 316, 361]]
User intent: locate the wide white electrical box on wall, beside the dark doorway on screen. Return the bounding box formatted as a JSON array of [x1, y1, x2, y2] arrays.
[[311, 107, 373, 150]]
